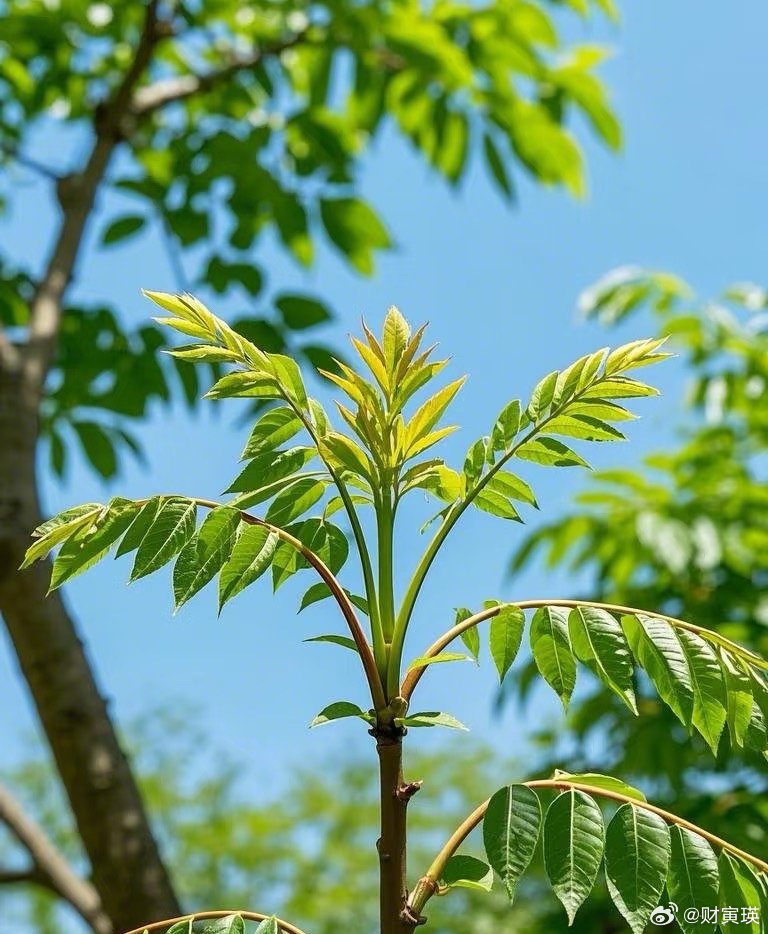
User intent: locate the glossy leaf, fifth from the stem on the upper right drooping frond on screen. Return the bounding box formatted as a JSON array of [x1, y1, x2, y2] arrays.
[[621, 613, 693, 726]]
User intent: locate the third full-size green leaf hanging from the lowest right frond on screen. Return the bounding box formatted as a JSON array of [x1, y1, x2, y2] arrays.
[[605, 804, 671, 934]]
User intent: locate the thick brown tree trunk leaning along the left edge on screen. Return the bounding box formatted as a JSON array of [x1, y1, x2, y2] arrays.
[[0, 367, 180, 932]]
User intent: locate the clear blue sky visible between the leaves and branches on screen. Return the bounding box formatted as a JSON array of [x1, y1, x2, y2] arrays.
[[0, 0, 768, 832]]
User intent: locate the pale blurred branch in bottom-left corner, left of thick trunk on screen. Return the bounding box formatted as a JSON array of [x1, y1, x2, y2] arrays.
[[0, 784, 113, 934]]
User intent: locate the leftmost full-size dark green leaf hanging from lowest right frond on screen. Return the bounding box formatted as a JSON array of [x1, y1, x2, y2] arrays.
[[483, 785, 541, 902]]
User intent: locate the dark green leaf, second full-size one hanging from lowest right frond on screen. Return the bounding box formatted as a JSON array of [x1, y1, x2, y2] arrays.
[[544, 788, 605, 925]]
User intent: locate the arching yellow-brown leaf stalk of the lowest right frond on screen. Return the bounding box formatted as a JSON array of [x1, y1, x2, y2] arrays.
[[408, 778, 768, 917]]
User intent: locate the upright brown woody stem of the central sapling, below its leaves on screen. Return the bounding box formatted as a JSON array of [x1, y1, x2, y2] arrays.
[[376, 737, 413, 934]]
